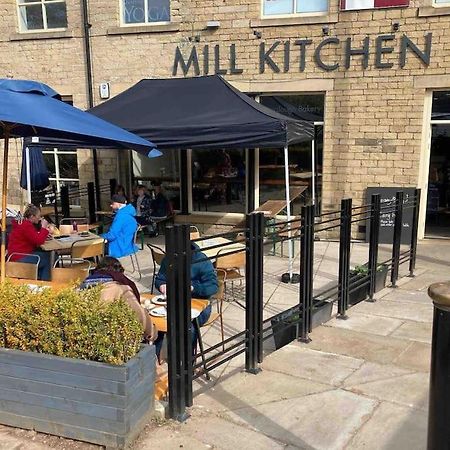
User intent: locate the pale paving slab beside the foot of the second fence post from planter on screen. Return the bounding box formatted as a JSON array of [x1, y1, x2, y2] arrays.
[[262, 344, 363, 386]]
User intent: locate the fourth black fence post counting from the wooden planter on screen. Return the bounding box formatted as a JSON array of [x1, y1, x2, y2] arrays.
[[337, 198, 352, 319]]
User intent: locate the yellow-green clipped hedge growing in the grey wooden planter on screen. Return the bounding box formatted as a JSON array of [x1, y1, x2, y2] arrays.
[[0, 282, 143, 365]]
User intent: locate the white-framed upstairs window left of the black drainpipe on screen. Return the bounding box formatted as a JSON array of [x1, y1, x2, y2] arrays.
[[18, 0, 67, 31]]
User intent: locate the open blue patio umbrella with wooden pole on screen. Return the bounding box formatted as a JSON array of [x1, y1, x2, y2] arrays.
[[0, 79, 161, 282]]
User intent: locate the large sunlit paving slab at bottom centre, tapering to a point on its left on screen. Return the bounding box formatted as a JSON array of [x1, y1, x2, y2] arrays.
[[226, 389, 377, 450]]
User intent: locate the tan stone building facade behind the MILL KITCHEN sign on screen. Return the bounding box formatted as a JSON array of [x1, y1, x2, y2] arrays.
[[0, 0, 450, 237]]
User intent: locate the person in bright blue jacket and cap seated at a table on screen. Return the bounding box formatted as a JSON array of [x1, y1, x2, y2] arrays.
[[102, 194, 138, 258]]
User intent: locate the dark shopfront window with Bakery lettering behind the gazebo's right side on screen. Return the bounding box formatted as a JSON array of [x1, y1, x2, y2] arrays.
[[259, 94, 325, 215]]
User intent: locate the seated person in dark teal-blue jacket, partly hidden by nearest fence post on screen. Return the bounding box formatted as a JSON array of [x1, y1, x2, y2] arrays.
[[155, 242, 219, 356]]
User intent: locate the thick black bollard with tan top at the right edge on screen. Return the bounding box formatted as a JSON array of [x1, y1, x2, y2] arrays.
[[427, 282, 450, 450]]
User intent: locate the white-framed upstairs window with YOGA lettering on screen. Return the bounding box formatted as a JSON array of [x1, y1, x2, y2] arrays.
[[120, 0, 170, 25]]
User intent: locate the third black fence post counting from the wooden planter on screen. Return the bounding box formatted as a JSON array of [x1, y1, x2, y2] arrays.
[[299, 205, 315, 342]]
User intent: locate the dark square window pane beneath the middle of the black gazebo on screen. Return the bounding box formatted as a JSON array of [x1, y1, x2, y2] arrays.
[[192, 149, 245, 213]]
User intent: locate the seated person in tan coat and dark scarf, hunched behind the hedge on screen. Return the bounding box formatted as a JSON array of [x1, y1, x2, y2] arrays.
[[80, 256, 156, 341]]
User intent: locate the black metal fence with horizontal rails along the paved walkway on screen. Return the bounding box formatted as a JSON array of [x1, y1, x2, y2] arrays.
[[166, 189, 420, 420]]
